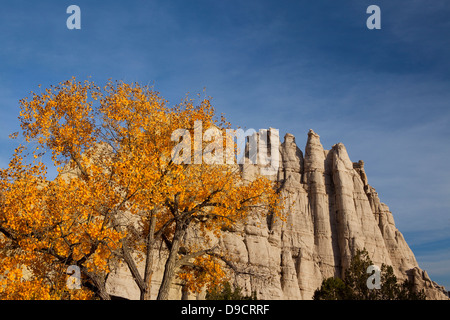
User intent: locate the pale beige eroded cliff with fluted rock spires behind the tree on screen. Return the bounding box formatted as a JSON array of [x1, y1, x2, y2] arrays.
[[104, 130, 447, 299]]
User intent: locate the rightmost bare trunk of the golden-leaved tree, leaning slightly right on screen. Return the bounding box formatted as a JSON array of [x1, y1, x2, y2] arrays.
[[157, 220, 186, 300]]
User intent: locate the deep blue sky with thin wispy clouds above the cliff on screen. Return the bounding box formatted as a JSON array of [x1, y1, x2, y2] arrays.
[[0, 0, 450, 289]]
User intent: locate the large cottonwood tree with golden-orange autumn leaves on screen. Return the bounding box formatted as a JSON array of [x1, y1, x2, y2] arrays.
[[0, 79, 282, 299]]
